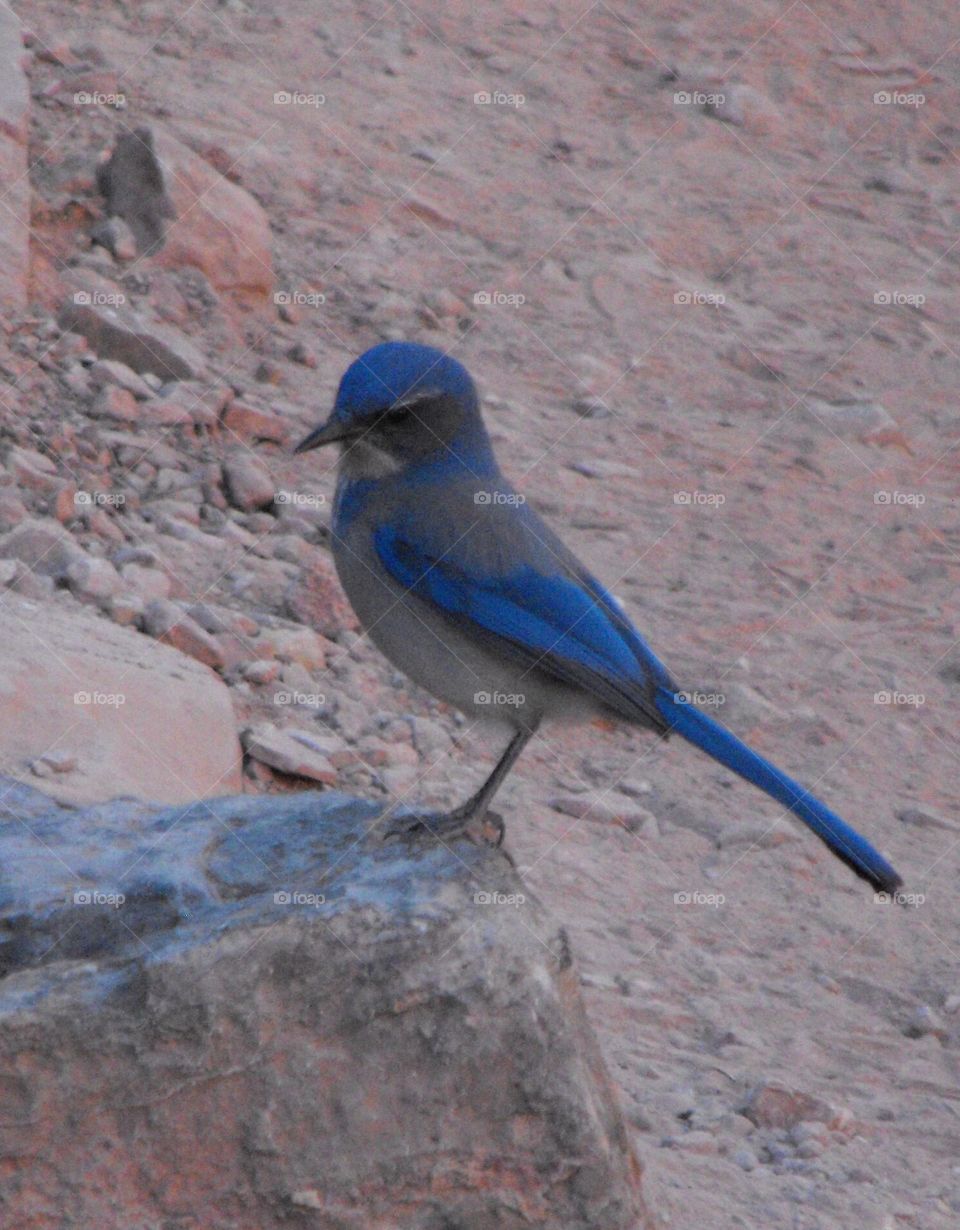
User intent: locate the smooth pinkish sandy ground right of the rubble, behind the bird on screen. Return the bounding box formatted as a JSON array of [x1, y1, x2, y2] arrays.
[[17, 0, 960, 1230]]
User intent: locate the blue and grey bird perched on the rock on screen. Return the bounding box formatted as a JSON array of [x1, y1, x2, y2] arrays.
[[297, 342, 902, 892]]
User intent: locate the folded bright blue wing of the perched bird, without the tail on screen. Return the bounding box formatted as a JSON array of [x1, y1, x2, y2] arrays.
[[373, 524, 670, 731]]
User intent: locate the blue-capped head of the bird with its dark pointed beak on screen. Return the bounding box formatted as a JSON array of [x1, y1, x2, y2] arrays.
[[295, 342, 492, 477]]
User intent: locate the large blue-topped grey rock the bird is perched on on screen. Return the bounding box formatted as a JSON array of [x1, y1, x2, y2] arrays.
[[0, 781, 651, 1230]]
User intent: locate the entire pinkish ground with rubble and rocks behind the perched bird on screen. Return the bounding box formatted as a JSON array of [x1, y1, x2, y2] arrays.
[[0, 0, 960, 1230]]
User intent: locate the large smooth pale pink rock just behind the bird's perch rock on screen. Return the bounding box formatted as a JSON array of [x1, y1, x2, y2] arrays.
[[0, 593, 241, 803]]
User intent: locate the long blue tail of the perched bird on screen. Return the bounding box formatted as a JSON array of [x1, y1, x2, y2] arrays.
[[656, 688, 903, 893]]
